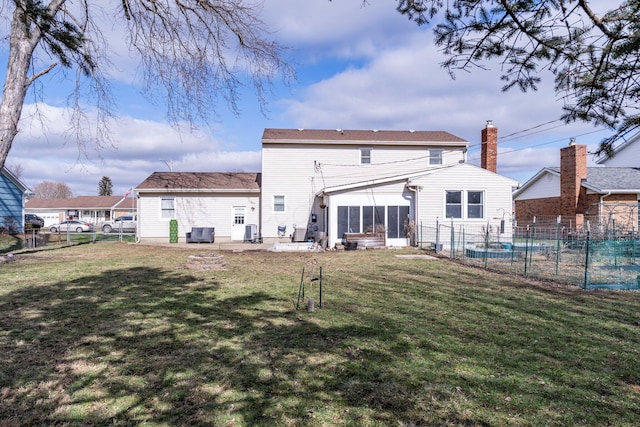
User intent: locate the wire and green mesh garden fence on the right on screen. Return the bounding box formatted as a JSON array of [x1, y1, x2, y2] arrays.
[[416, 222, 640, 290]]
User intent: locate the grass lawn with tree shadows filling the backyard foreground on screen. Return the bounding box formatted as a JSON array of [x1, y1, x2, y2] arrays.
[[0, 243, 640, 426]]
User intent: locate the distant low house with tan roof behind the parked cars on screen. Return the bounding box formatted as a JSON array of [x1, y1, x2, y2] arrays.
[[25, 196, 137, 227]]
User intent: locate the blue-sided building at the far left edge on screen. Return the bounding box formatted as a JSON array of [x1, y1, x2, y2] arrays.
[[0, 167, 32, 233]]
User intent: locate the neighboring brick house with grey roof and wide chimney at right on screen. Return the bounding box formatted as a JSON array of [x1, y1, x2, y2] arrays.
[[513, 141, 640, 233]]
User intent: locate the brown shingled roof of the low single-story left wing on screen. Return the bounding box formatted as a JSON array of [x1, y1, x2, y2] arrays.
[[135, 172, 262, 192]]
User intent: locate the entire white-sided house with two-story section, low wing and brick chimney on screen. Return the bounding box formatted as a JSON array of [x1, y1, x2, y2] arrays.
[[135, 122, 518, 246]]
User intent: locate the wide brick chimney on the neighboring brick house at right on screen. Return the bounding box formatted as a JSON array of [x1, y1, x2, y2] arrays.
[[560, 138, 587, 227]]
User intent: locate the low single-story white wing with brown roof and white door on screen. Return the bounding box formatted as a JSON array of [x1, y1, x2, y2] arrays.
[[135, 172, 260, 241]]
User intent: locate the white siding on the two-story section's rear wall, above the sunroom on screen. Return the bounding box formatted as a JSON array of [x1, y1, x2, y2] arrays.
[[262, 143, 465, 238]]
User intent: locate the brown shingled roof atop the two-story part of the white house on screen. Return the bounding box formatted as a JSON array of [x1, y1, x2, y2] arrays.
[[262, 128, 469, 147]]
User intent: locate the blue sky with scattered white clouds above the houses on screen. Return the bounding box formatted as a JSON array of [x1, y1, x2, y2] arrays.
[[3, 0, 609, 195]]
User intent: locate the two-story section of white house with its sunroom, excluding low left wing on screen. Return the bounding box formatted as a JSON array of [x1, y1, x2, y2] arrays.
[[261, 124, 518, 246]]
